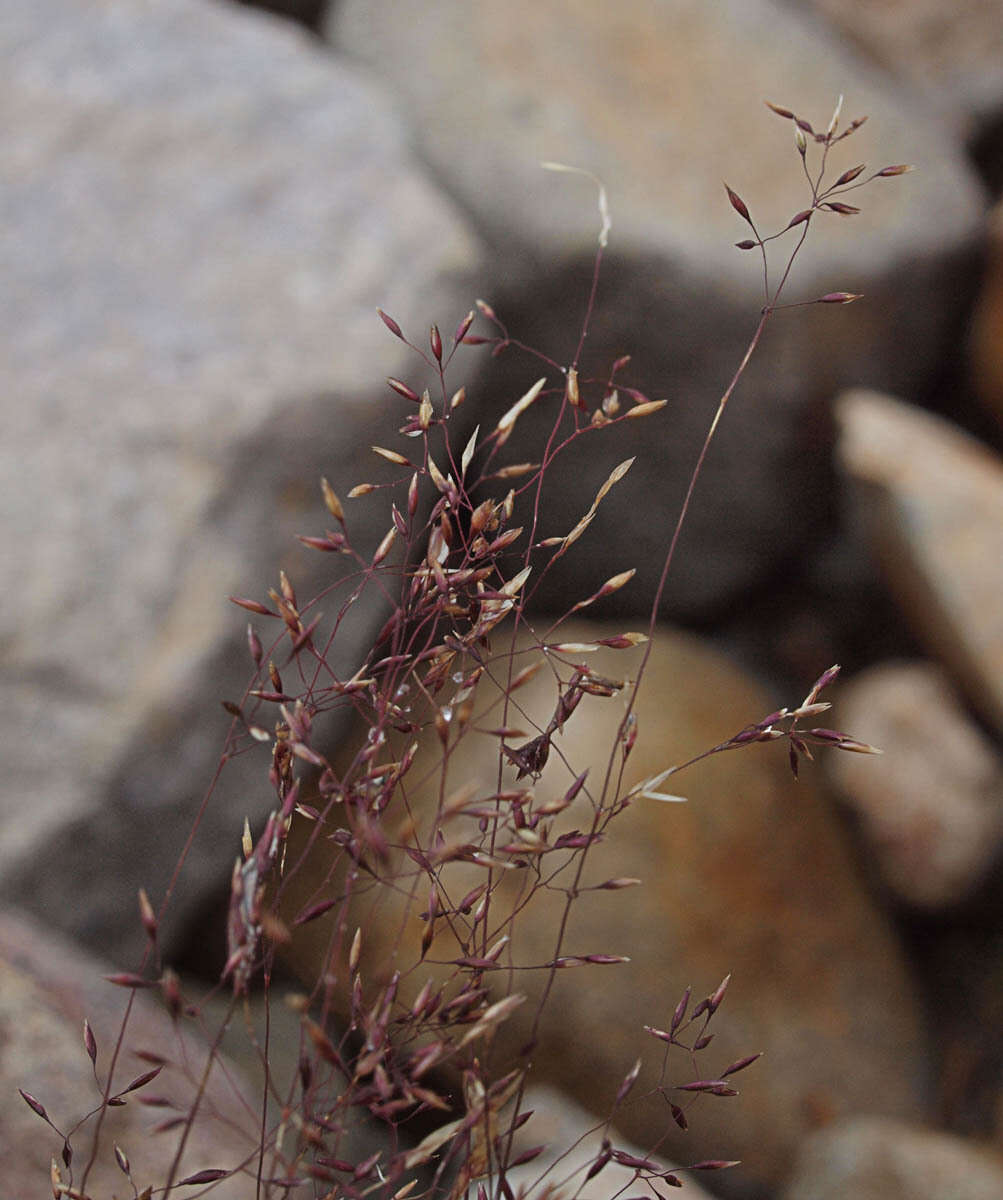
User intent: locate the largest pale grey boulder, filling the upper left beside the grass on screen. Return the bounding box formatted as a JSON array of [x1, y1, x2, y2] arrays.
[[0, 0, 479, 958]]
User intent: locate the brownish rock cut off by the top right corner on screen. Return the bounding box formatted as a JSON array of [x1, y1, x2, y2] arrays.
[[798, 0, 1003, 136]]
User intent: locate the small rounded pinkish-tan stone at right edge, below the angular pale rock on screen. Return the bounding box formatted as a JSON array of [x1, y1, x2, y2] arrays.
[[827, 662, 1003, 910]]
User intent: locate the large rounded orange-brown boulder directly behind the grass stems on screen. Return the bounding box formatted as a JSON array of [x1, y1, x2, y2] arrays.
[[278, 622, 927, 1195]]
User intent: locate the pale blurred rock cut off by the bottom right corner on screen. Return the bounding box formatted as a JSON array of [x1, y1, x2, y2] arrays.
[[783, 1115, 1003, 1200]]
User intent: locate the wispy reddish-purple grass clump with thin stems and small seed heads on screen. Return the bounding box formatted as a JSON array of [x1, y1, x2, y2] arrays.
[[22, 101, 909, 1200]]
